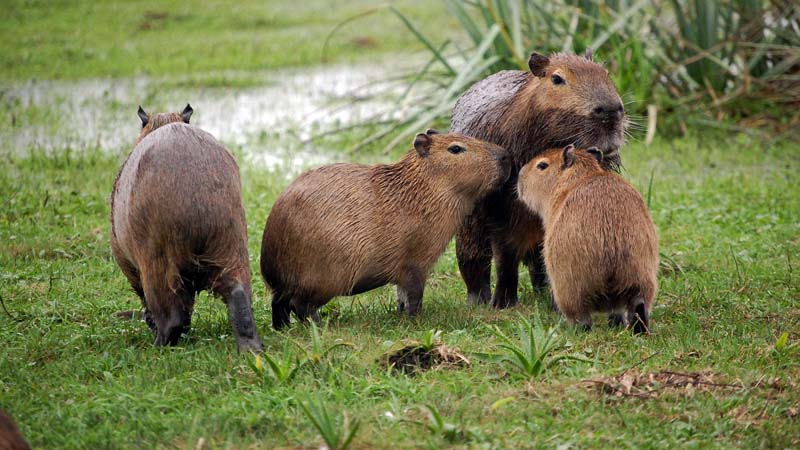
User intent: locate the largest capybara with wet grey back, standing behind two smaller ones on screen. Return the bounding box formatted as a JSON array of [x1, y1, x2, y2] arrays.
[[450, 53, 627, 308]]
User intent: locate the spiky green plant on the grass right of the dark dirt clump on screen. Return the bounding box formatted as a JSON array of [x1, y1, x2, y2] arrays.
[[480, 316, 590, 378]]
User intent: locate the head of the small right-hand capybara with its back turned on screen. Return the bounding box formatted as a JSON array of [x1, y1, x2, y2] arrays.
[[517, 145, 603, 216]]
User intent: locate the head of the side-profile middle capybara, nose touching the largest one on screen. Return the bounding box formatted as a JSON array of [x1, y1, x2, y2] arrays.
[[414, 130, 511, 199]]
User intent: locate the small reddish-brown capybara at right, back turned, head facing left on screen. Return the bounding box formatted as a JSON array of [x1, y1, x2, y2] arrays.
[[517, 145, 658, 333]]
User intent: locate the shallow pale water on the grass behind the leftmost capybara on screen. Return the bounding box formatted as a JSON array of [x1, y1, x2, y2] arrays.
[[0, 65, 396, 173]]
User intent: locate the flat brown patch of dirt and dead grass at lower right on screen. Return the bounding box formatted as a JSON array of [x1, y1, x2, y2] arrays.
[[585, 370, 746, 398]]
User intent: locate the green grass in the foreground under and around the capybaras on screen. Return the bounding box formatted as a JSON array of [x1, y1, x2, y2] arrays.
[[0, 132, 800, 448]]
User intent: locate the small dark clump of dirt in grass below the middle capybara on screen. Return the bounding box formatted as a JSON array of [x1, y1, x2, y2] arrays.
[[380, 343, 470, 375]]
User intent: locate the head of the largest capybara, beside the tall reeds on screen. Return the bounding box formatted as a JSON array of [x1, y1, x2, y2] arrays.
[[522, 53, 628, 162]]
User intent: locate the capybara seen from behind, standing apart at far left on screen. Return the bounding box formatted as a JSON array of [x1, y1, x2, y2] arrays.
[[111, 105, 262, 351]]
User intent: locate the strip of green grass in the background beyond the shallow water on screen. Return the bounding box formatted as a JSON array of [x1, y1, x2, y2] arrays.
[[0, 0, 455, 81]]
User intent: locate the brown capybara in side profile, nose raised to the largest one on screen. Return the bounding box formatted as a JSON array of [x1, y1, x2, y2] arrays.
[[261, 130, 510, 329]]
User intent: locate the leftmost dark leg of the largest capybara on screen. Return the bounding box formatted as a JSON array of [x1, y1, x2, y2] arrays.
[[456, 206, 492, 304]]
